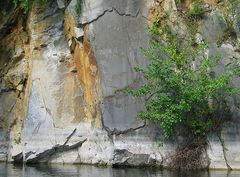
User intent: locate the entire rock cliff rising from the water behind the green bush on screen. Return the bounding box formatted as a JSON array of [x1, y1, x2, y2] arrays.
[[0, 0, 240, 169]]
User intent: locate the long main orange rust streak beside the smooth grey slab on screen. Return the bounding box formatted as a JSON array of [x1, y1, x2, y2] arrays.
[[73, 28, 100, 125]]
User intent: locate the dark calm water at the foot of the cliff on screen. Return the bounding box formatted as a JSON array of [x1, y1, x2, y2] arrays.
[[0, 163, 237, 177]]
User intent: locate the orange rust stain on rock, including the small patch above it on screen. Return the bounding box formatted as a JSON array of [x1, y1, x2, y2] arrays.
[[64, 11, 102, 127]]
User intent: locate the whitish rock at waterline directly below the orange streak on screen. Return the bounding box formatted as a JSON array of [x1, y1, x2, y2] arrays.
[[45, 123, 114, 165]]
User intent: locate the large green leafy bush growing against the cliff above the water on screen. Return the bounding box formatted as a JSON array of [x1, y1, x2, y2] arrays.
[[127, 19, 239, 138]]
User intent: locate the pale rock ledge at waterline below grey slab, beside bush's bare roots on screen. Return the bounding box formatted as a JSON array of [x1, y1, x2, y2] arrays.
[[112, 124, 177, 166]]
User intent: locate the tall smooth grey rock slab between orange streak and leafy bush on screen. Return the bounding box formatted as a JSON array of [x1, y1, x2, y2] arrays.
[[85, 1, 150, 134]]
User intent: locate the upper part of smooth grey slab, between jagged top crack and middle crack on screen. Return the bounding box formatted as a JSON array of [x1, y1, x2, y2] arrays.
[[89, 11, 148, 97]]
